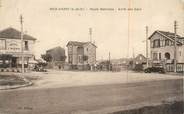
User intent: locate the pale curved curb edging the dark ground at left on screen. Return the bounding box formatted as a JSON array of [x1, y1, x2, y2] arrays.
[[0, 82, 33, 90]]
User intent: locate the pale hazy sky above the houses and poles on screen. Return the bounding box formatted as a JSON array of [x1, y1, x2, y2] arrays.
[[0, 0, 184, 59]]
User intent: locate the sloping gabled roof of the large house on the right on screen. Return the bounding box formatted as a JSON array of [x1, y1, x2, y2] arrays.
[[148, 30, 184, 44]]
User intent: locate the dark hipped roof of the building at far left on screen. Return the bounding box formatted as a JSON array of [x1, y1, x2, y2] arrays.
[[0, 27, 36, 40]]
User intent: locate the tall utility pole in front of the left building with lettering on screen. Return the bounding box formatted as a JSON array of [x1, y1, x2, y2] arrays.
[[20, 15, 24, 73]]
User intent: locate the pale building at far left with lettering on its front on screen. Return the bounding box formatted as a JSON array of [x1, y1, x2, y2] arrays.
[[0, 28, 36, 67]]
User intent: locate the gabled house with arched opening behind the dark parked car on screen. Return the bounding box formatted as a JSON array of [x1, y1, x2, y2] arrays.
[[149, 30, 184, 70]]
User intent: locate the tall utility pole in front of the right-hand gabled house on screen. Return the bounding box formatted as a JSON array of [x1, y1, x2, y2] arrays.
[[174, 21, 177, 72]]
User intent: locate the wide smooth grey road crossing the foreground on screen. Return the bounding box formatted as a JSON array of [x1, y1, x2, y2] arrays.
[[0, 79, 183, 114]]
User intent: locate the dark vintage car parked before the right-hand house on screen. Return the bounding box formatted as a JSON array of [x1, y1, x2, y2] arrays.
[[144, 67, 165, 73]]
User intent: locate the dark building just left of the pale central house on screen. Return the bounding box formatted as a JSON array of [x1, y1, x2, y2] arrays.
[[46, 46, 66, 69]]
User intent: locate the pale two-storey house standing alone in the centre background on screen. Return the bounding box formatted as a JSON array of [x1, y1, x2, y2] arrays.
[[67, 41, 97, 69]]
